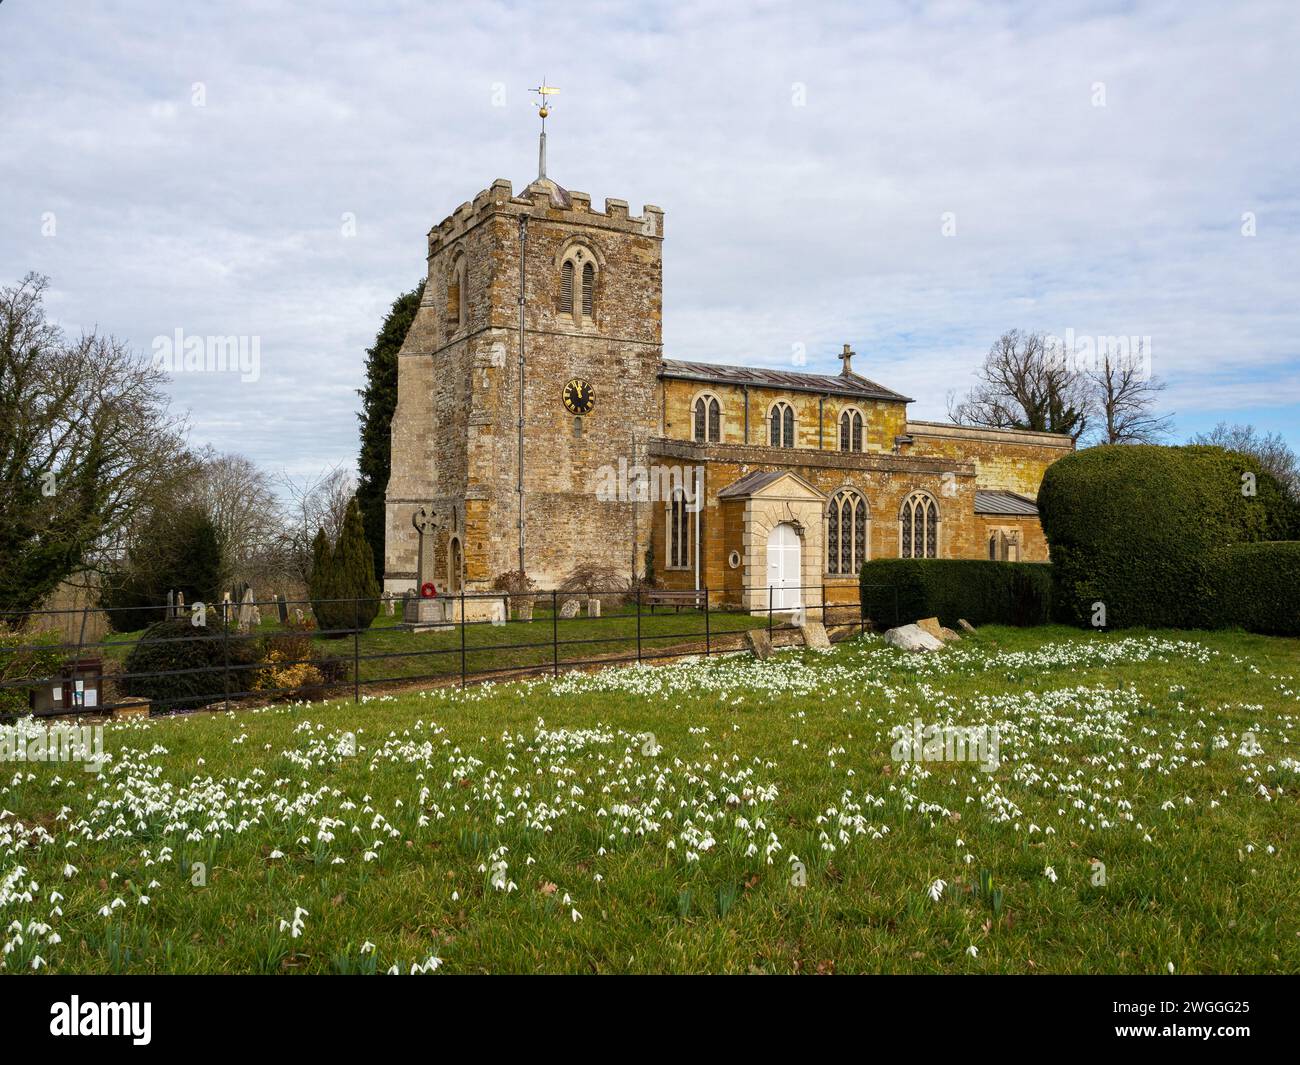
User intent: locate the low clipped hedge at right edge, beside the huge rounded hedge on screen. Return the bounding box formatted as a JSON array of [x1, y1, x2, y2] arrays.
[[1214, 540, 1300, 636]]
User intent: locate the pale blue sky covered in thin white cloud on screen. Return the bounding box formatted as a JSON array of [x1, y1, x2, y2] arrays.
[[0, 0, 1300, 475]]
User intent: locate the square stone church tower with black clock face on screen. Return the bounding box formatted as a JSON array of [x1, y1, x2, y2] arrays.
[[384, 157, 663, 594]]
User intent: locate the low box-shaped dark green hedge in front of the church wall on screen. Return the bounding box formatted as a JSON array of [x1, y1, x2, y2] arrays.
[[859, 558, 1052, 628]]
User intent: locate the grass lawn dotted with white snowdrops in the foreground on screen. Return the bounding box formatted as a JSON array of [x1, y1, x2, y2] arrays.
[[0, 624, 1300, 974]]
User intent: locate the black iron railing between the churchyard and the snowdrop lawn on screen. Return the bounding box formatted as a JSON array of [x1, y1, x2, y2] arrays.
[[0, 584, 866, 715]]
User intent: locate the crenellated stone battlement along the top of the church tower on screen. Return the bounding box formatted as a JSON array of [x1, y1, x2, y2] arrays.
[[429, 178, 663, 256]]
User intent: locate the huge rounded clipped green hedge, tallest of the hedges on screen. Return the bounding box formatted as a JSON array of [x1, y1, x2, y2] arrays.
[[1039, 445, 1300, 628]]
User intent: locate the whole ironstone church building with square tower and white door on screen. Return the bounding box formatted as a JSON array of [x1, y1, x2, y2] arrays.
[[385, 118, 1074, 610]]
